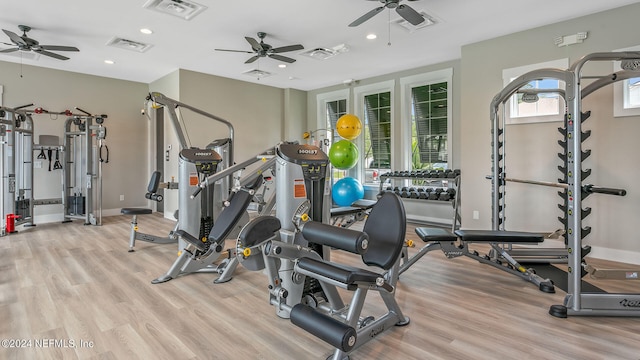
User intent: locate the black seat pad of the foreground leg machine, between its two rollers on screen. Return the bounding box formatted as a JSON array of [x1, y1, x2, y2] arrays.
[[298, 257, 381, 285]]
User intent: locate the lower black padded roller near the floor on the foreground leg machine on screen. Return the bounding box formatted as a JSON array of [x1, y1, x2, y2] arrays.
[[291, 304, 358, 352]]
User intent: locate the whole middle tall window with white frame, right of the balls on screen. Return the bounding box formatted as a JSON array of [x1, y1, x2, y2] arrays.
[[354, 80, 395, 184]]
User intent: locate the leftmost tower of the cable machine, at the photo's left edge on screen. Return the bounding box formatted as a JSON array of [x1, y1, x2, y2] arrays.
[[0, 105, 34, 236]]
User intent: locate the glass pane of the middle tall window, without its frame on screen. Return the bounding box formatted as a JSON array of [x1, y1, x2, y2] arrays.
[[361, 91, 391, 183]]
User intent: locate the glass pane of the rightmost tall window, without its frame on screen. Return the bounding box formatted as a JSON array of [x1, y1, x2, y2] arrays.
[[411, 82, 449, 170]]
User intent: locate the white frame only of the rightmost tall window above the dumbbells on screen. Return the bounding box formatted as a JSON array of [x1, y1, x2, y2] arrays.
[[400, 68, 453, 170]]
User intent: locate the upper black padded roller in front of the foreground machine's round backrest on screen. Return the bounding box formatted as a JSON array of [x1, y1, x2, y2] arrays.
[[302, 221, 369, 255]]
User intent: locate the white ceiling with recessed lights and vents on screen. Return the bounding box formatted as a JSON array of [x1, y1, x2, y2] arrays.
[[0, 0, 638, 90]]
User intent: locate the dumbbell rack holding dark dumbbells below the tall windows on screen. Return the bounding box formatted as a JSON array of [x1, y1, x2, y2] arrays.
[[380, 170, 460, 228]]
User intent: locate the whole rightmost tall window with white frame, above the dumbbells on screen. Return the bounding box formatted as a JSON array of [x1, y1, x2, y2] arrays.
[[400, 68, 453, 174]]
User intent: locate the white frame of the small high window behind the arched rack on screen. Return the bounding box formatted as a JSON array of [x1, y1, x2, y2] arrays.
[[502, 58, 569, 125]]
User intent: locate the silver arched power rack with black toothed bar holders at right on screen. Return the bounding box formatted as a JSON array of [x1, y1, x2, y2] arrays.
[[490, 52, 640, 317]]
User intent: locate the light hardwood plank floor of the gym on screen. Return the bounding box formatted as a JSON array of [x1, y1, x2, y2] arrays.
[[0, 215, 640, 360]]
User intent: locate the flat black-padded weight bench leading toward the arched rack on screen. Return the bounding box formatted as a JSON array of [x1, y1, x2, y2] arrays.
[[400, 227, 555, 293]]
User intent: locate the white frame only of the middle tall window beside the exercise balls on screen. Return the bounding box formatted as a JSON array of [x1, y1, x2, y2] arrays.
[[353, 80, 396, 185]]
